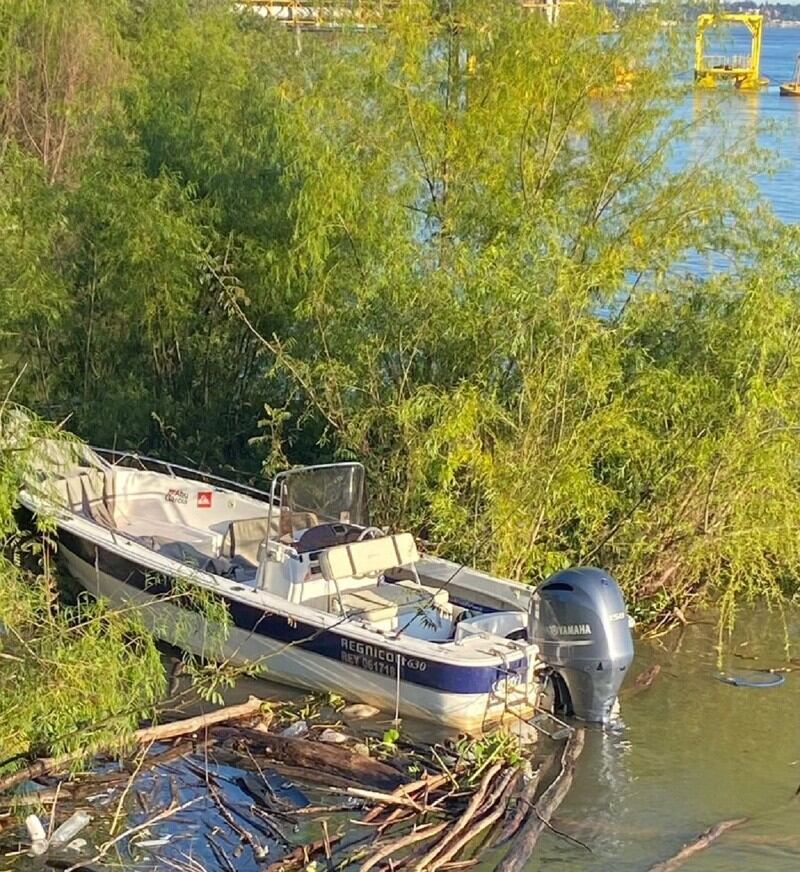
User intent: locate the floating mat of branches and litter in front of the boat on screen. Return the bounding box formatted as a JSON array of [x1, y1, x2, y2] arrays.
[[0, 698, 580, 872]]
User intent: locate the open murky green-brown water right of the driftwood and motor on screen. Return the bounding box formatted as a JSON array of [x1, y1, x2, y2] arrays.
[[538, 614, 800, 872]]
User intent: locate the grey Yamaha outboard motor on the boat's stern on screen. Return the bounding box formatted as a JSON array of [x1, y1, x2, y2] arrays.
[[528, 567, 633, 721]]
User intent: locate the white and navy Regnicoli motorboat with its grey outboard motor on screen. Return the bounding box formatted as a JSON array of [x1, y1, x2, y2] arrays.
[[20, 443, 633, 733]]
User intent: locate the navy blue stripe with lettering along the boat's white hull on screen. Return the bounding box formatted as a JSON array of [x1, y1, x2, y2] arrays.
[[59, 530, 527, 694]]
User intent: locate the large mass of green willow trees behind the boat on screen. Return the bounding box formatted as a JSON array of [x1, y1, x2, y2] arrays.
[[0, 0, 800, 621]]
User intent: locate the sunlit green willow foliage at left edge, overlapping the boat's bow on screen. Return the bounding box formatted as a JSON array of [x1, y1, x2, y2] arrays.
[[0, 403, 165, 769]]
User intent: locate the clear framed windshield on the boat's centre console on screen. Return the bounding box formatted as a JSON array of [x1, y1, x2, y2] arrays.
[[273, 463, 369, 539]]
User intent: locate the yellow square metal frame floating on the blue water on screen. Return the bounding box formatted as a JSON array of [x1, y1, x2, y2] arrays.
[[694, 12, 769, 90]]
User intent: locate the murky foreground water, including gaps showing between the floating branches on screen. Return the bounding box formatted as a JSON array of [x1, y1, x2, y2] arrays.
[[0, 610, 800, 872]]
